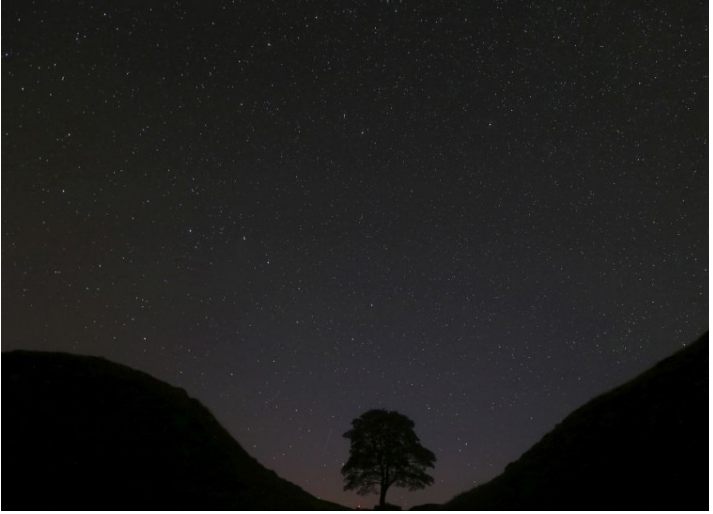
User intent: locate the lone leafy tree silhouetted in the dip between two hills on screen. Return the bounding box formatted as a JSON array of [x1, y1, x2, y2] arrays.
[[342, 409, 436, 508]]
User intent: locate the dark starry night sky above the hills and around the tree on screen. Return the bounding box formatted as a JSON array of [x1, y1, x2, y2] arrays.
[[2, 0, 709, 506]]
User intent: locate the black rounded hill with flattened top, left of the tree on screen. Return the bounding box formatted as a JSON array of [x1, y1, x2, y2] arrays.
[[2, 351, 347, 512]]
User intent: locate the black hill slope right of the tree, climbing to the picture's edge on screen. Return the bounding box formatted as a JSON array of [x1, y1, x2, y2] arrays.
[[443, 333, 713, 512]]
